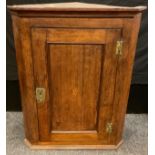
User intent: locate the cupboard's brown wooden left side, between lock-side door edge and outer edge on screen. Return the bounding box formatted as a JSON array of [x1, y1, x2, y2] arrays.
[[12, 15, 38, 142]]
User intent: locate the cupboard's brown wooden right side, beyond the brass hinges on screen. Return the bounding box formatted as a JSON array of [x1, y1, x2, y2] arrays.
[[113, 14, 141, 144]]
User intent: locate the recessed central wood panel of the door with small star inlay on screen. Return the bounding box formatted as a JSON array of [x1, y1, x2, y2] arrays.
[[48, 44, 103, 132]]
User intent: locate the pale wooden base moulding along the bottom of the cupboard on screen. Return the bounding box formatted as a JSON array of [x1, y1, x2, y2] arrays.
[[24, 139, 123, 150]]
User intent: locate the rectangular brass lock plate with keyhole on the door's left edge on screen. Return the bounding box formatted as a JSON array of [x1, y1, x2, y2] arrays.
[[36, 88, 45, 103]]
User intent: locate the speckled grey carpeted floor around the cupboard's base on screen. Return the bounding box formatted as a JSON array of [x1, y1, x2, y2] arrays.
[[6, 112, 148, 155]]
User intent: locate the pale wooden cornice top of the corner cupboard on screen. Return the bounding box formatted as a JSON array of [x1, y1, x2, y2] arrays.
[[8, 2, 146, 11]]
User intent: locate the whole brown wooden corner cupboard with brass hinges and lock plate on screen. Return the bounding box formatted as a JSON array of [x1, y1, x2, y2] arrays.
[[8, 3, 146, 149]]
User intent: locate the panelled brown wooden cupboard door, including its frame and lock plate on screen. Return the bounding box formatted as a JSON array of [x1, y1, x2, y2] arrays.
[[31, 28, 121, 144]]
